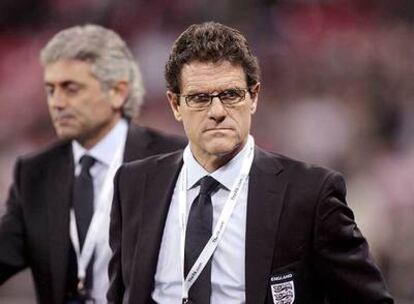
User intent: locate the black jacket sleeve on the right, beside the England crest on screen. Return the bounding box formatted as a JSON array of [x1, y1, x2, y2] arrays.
[[314, 173, 393, 304]]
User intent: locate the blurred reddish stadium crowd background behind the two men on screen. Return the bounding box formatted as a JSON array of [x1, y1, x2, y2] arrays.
[[0, 0, 414, 304]]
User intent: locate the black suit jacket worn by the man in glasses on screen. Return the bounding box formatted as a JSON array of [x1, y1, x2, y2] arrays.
[[108, 148, 393, 304]]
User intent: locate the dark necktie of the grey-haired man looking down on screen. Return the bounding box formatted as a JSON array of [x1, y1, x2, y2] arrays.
[[67, 155, 95, 298]]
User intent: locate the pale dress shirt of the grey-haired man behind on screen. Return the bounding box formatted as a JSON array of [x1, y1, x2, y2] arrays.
[[72, 119, 128, 304]]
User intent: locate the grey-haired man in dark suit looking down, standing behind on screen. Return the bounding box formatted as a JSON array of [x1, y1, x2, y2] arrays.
[[0, 25, 185, 304]]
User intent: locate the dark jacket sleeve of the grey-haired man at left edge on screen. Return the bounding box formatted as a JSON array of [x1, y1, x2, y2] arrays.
[[0, 161, 27, 284]]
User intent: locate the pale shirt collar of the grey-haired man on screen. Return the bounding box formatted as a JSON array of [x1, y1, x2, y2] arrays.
[[72, 119, 128, 167]]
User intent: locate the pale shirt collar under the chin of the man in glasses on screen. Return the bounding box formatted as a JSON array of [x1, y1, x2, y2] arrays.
[[183, 135, 251, 190]]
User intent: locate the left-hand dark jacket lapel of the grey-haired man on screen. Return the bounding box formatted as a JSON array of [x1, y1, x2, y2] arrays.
[[45, 145, 74, 303]]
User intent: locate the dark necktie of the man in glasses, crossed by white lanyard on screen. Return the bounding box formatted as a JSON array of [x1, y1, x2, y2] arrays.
[[184, 176, 219, 304]]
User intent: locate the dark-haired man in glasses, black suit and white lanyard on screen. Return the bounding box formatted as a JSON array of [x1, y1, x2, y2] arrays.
[[108, 22, 393, 304]]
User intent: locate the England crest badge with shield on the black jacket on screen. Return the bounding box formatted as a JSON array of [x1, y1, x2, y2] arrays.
[[270, 273, 295, 304]]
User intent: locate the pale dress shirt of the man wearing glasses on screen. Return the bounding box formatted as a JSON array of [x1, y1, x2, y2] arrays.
[[152, 139, 248, 304]]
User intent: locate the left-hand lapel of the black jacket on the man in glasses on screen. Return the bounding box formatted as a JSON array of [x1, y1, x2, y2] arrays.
[[130, 151, 183, 303]]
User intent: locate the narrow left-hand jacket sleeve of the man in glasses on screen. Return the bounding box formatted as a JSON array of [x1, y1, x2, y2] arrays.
[[107, 166, 125, 304]]
